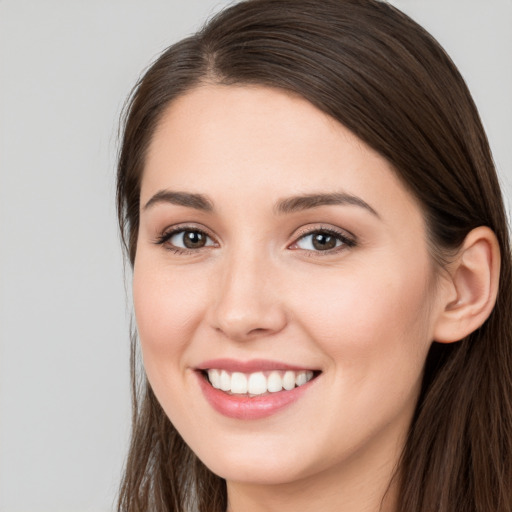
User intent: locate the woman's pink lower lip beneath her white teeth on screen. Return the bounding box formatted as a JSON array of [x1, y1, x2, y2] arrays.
[[197, 372, 316, 420]]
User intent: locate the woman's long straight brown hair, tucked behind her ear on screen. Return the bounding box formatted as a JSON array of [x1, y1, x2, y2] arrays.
[[117, 0, 512, 512]]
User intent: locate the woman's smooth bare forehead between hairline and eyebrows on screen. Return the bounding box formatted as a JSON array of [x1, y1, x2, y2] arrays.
[[141, 85, 418, 224]]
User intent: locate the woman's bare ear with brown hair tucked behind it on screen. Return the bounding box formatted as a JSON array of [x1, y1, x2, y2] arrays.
[[434, 226, 500, 343]]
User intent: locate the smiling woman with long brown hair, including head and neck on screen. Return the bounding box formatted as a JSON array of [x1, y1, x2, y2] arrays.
[[118, 0, 512, 512]]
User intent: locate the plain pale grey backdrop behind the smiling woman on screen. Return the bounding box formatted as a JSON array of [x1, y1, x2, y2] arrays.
[[0, 0, 512, 512]]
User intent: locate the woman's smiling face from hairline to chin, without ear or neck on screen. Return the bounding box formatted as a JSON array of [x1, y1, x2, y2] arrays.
[[133, 85, 446, 484]]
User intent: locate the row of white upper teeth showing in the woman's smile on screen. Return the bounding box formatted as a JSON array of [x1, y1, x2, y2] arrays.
[[208, 369, 313, 395]]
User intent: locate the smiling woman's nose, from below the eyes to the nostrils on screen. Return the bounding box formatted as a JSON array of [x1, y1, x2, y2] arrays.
[[210, 249, 287, 341]]
